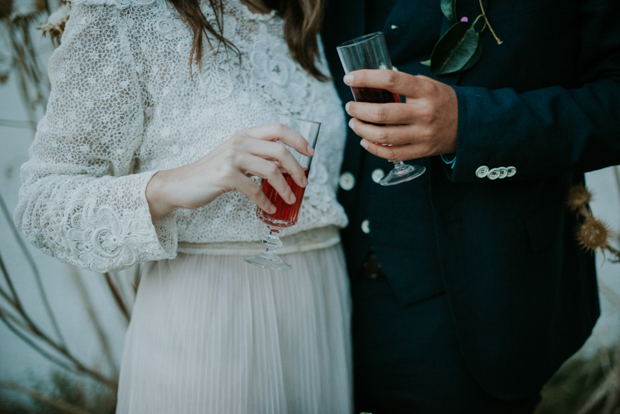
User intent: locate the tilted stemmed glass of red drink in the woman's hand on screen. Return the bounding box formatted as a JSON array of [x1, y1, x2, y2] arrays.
[[244, 115, 321, 270]]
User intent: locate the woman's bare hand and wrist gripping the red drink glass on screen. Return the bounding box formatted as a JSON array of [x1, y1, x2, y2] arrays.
[[146, 123, 314, 222]]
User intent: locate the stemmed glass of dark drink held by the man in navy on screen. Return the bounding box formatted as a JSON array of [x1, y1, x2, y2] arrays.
[[336, 32, 426, 185]]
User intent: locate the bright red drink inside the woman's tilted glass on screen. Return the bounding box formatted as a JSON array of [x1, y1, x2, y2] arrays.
[[256, 169, 310, 228]]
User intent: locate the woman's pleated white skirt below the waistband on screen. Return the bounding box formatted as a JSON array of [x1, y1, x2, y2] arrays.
[[116, 244, 352, 414]]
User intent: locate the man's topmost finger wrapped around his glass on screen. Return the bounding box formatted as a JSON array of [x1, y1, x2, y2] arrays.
[[343, 69, 423, 97]]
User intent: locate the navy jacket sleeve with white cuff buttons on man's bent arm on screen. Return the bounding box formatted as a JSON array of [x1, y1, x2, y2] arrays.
[[445, 0, 620, 183]]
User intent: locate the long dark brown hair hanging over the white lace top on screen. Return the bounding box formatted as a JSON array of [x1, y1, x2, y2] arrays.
[[168, 0, 328, 80]]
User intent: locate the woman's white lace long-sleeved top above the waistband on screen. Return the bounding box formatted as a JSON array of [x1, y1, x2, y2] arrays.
[[15, 0, 346, 271]]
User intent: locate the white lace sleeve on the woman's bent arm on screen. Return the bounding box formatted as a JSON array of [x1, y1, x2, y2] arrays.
[[15, 5, 177, 272]]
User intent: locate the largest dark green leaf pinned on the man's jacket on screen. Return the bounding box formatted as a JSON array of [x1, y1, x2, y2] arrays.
[[431, 22, 480, 76]]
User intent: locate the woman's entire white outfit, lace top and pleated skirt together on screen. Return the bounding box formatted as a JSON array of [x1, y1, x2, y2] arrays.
[[15, 0, 351, 414]]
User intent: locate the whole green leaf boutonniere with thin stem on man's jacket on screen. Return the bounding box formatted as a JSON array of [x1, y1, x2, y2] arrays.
[[422, 0, 502, 76]]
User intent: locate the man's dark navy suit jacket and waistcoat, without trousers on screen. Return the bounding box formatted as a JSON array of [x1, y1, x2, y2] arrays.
[[322, 0, 620, 398]]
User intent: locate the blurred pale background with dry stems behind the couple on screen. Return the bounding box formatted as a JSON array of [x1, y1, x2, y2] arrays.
[[0, 0, 620, 414]]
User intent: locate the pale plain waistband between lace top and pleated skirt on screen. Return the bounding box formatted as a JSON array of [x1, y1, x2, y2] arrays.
[[177, 226, 340, 256]]
